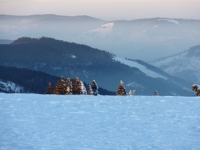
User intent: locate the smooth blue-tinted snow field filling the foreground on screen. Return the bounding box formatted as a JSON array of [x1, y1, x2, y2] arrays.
[[0, 93, 200, 150]]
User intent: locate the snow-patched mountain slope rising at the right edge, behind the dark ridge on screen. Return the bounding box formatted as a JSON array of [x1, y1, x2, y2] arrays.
[[150, 45, 200, 84]]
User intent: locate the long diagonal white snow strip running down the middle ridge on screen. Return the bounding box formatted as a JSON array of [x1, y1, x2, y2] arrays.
[[113, 57, 167, 80]]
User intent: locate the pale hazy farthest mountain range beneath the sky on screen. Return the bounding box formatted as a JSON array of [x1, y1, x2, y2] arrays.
[[0, 15, 200, 61]]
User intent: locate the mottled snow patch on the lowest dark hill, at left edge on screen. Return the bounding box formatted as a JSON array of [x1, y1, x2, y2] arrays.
[[0, 80, 24, 93]]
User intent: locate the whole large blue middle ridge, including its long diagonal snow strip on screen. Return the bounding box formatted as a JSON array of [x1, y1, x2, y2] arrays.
[[0, 37, 193, 95]]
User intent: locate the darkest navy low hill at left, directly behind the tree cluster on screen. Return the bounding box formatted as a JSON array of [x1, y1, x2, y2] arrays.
[[0, 66, 115, 95]]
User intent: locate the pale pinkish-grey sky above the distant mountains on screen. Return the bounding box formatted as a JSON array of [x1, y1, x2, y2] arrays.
[[0, 0, 200, 20]]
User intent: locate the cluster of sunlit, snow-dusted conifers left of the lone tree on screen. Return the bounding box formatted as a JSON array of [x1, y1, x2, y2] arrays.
[[46, 76, 98, 95]]
